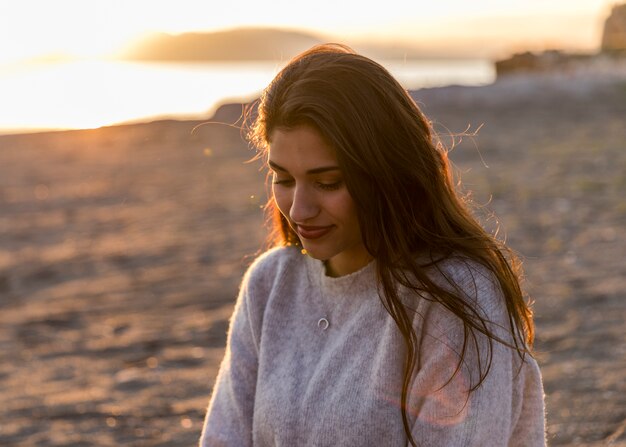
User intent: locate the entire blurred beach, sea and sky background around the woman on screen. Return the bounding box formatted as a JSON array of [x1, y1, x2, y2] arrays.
[[0, 0, 626, 446]]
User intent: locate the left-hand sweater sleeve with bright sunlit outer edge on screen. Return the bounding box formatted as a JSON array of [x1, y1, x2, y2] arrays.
[[200, 268, 259, 447]]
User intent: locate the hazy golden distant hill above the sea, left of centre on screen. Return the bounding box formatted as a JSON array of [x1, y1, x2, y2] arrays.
[[121, 28, 325, 62]]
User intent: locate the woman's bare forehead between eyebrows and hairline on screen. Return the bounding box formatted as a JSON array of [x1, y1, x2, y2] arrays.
[[269, 126, 337, 171]]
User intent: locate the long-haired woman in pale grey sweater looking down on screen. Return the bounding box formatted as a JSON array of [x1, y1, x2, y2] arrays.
[[201, 44, 545, 446]]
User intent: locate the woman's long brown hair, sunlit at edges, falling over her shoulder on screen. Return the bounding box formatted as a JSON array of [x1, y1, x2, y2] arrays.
[[249, 44, 534, 445]]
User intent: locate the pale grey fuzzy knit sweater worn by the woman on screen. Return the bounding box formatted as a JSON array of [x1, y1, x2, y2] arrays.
[[200, 247, 545, 447]]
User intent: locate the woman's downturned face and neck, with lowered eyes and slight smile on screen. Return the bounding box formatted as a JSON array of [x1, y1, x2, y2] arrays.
[[269, 126, 371, 276]]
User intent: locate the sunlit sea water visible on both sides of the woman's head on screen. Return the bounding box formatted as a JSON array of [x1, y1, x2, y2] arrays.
[[0, 59, 495, 134]]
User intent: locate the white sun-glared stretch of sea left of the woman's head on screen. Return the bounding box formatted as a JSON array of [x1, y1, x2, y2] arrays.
[[0, 61, 275, 130]]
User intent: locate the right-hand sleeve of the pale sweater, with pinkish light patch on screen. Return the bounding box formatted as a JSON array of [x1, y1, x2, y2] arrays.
[[408, 262, 545, 447]]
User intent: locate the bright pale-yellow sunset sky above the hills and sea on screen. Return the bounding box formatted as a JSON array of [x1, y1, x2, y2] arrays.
[[0, 0, 615, 64]]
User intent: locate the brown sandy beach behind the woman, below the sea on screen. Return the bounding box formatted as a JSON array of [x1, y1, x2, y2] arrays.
[[0, 75, 626, 446]]
